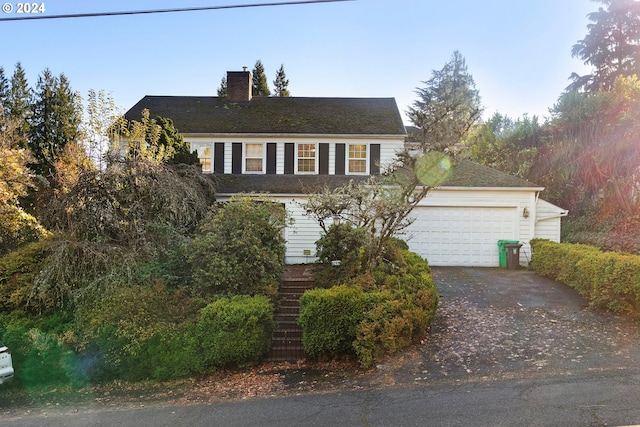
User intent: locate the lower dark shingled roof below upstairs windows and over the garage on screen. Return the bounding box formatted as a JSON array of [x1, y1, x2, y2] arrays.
[[216, 160, 541, 194]]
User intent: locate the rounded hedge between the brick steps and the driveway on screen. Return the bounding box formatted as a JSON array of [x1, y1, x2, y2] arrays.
[[298, 250, 438, 366]]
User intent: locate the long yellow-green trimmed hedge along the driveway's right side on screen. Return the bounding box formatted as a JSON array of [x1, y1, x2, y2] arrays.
[[530, 239, 640, 317]]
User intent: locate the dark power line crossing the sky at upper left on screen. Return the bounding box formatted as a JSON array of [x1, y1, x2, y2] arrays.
[[0, 0, 355, 21]]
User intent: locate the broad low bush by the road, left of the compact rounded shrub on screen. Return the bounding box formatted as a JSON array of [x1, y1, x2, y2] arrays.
[[68, 285, 198, 380]]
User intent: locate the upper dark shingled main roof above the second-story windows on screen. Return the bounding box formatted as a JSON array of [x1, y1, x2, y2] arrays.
[[125, 96, 406, 135]]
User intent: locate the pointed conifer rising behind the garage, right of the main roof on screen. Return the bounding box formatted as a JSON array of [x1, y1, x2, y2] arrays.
[[407, 51, 482, 152]]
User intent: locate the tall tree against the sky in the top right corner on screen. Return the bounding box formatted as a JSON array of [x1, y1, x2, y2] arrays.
[[568, 0, 640, 92]]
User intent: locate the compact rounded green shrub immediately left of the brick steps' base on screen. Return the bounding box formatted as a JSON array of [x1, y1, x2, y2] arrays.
[[195, 295, 274, 370]]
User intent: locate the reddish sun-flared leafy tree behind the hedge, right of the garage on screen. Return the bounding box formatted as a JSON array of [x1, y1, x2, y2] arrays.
[[532, 76, 640, 214]]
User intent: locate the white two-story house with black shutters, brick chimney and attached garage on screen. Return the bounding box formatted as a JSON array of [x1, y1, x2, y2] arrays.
[[125, 71, 566, 266]]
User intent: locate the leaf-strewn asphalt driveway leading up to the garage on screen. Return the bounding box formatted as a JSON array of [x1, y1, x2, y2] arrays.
[[381, 267, 640, 384]]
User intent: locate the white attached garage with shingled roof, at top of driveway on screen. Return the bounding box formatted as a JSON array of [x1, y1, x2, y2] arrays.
[[404, 161, 567, 267]]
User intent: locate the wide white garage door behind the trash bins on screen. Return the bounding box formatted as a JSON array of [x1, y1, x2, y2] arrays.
[[407, 207, 517, 267]]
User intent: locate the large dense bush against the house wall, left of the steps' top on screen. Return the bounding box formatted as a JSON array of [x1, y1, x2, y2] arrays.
[[188, 196, 286, 299]]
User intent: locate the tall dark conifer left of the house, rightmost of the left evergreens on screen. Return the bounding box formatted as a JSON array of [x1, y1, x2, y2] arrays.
[[29, 69, 82, 177]]
